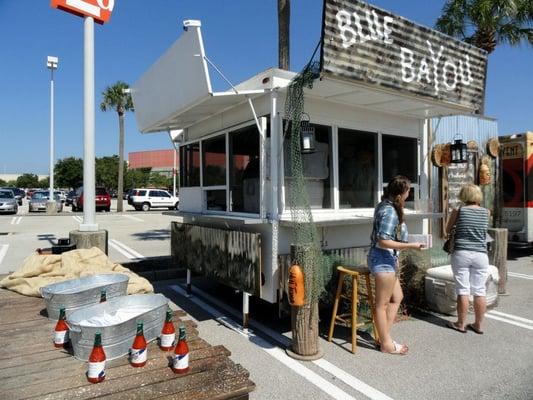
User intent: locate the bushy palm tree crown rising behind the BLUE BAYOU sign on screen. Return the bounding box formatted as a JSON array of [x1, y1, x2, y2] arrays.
[[436, 0, 533, 54]]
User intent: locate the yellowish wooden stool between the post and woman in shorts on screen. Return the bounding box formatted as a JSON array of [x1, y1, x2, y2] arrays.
[[328, 265, 379, 353]]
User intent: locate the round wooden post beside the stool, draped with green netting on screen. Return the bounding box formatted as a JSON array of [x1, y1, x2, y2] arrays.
[[286, 245, 324, 361]]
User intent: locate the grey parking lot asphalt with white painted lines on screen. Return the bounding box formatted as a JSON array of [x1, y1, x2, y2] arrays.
[[0, 205, 533, 400]]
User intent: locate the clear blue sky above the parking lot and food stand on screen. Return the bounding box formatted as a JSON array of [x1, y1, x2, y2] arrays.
[[0, 0, 533, 174]]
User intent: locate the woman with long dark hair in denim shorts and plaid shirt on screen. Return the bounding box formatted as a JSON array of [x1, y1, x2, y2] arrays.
[[368, 175, 423, 355]]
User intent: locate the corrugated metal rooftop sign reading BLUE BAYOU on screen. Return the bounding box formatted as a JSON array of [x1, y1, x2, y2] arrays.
[[321, 0, 487, 112]]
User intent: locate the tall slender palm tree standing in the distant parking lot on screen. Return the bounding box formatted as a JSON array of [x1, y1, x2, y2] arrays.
[[100, 81, 134, 212]]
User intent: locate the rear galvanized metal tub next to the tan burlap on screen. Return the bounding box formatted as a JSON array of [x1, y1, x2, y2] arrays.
[[41, 274, 130, 320]]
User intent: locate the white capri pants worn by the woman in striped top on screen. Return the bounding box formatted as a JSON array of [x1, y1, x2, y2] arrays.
[[452, 250, 489, 296]]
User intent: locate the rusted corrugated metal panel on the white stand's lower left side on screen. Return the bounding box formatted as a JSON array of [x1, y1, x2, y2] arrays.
[[171, 222, 261, 296]]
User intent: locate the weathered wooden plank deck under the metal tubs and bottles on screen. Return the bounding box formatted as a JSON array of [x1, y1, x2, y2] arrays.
[[0, 289, 255, 400]]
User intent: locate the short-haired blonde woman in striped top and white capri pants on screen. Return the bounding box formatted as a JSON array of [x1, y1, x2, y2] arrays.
[[446, 184, 490, 334]]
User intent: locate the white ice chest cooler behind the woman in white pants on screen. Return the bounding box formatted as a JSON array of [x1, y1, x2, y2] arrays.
[[425, 265, 500, 315]]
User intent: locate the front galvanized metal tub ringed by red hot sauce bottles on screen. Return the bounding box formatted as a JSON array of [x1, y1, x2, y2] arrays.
[[67, 294, 168, 361]]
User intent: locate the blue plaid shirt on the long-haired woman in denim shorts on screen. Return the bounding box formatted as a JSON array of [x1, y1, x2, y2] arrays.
[[370, 200, 408, 247]]
